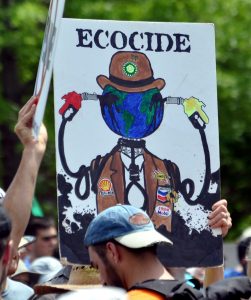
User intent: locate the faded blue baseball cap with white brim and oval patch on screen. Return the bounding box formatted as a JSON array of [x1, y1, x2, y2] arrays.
[[84, 205, 172, 249]]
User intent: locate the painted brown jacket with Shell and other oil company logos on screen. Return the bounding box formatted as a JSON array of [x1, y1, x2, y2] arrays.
[[91, 150, 179, 231]]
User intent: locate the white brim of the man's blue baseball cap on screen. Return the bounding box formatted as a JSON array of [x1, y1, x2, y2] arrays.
[[115, 230, 173, 249]]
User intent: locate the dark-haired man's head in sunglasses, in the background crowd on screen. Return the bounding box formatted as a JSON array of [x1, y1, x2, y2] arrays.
[[26, 217, 58, 258]]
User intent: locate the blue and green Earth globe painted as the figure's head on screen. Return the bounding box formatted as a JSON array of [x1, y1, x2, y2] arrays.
[[100, 86, 164, 139]]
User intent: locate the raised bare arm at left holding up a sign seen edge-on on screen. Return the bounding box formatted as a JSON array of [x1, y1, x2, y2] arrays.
[[3, 97, 47, 251]]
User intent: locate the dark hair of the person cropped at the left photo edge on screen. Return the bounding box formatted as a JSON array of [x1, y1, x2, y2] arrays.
[[0, 206, 11, 259]]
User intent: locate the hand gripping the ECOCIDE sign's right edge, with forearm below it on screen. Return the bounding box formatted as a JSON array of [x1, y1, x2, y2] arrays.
[[204, 199, 232, 287]]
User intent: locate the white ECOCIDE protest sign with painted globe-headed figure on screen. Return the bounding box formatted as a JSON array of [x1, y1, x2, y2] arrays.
[[54, 19, 222, 267]]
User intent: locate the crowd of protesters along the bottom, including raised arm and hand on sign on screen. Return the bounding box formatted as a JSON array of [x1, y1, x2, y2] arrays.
[[0, 97, 251, 300]]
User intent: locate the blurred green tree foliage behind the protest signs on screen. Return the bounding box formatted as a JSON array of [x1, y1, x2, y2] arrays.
[[0, 0, 251, 238]]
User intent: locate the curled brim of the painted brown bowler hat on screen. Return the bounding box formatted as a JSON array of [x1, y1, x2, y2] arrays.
[[97, 75, 166, 93]]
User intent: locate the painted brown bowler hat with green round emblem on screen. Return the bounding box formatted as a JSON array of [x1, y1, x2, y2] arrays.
[[97, 51, 166, 93]]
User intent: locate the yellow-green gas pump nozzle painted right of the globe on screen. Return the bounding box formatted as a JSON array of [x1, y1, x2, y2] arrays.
[[183, 97, 209, 124]]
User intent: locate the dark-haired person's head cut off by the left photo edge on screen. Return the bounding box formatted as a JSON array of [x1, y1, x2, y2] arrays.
[[0, 206, 11, 290]]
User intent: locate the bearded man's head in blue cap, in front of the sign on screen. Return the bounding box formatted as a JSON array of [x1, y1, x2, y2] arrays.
[[84, 205, 172, 288]]
